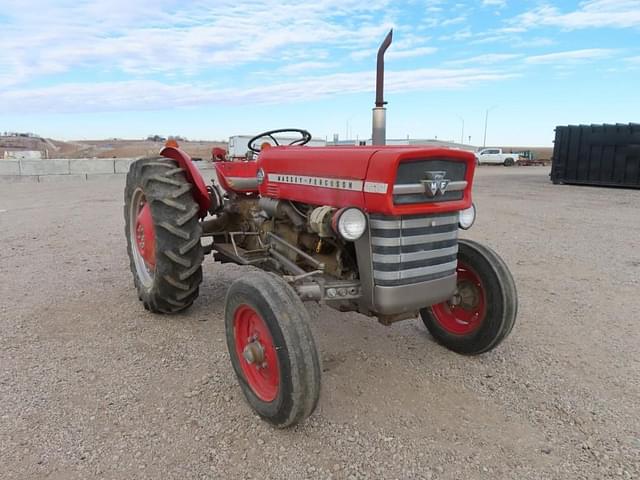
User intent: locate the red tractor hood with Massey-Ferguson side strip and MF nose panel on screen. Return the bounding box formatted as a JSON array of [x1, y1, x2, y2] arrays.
[[258, 146, 475, 215]]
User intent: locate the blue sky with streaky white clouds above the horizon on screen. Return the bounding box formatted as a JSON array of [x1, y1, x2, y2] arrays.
[[0, 0, 640, 146]]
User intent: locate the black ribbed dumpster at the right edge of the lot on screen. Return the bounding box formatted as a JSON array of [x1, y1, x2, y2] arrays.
[[551, 123, 640, 188]]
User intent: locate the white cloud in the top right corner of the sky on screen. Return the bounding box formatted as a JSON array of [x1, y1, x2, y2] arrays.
[[512, 0, 640, 30]]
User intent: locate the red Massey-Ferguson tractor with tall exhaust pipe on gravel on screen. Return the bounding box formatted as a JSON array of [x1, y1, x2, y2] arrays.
[[124, 33, 517, 427]]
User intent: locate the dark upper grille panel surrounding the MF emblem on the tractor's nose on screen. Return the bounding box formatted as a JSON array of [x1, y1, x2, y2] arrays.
[[393, 159, 467, 205]]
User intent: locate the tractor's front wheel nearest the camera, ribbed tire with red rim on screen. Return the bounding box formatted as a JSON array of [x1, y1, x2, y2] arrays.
[[225, 272, 320, 428]]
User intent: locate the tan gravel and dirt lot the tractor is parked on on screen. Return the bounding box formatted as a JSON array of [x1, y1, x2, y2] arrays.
[[0, 167, 640, 480]]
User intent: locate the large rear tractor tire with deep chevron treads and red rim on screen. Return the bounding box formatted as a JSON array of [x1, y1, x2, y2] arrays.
[[124, 157, 203, 313]]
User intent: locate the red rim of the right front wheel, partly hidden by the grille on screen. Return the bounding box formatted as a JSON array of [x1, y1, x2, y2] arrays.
[[431, 260, 487, 335]]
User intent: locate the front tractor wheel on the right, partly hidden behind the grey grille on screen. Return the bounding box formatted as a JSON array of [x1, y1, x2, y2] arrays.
[[420, 240, 518, 355]]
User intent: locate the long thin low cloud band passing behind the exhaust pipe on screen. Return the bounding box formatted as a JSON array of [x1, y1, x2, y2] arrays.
[[0, 68, 516, 113]]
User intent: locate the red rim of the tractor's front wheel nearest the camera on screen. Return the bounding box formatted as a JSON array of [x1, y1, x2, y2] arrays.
[[233, 305, 280, 402]]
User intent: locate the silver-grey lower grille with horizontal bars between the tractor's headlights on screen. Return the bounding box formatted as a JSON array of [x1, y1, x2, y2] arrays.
[[370, 212, 458, 286]]
